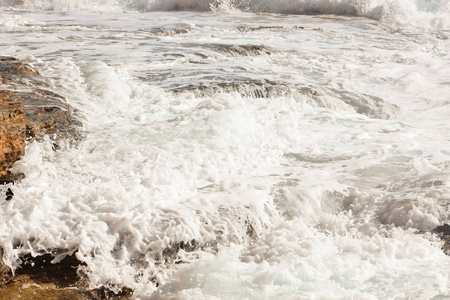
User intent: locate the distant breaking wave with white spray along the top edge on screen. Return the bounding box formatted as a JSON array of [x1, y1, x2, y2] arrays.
[[0, 0, 450, 30]]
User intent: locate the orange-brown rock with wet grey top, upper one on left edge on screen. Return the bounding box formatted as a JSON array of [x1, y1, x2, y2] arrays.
[[0, 56, 79, 183]]
